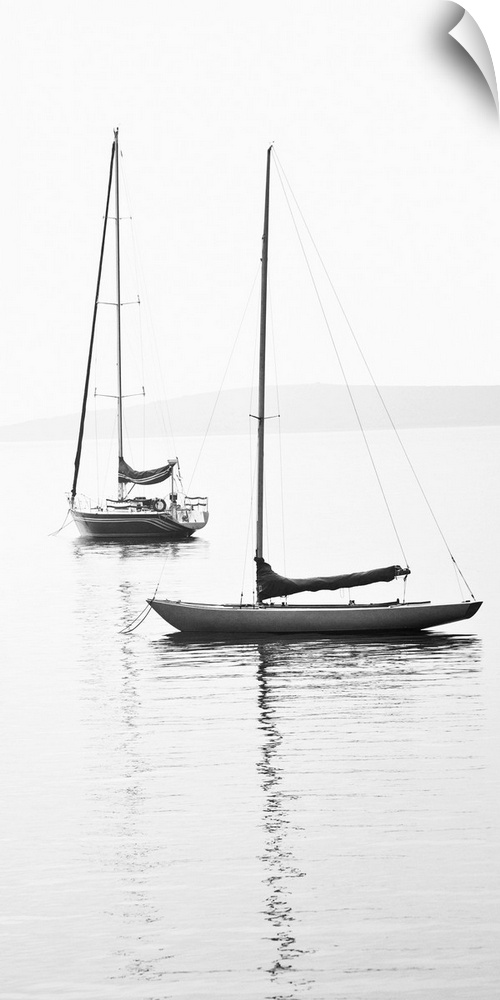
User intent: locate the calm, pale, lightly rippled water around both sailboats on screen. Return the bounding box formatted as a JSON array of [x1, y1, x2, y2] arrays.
[[0, 429, 500, 1000]]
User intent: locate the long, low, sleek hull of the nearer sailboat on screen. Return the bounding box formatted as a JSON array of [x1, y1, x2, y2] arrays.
[[148, 599, 481, 635]]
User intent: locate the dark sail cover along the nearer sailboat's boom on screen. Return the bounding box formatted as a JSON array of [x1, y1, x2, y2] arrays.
[[255, 558, 410, 601]]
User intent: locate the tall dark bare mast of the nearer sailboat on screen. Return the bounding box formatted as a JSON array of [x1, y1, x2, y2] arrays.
[[255, 146, 272, 588]]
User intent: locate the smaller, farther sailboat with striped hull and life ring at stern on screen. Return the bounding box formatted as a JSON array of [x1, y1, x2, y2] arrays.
[[68, 129, 208, 541]]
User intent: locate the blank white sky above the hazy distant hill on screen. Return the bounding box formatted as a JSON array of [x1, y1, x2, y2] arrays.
[[0, 0, 500, 424]]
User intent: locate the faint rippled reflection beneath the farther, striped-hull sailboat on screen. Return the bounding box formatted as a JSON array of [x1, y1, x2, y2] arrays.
[[73, 538, 170, 995]]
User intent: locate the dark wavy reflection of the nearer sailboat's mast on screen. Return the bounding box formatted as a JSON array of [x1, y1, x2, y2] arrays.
[[257, 644, 305, 1000]]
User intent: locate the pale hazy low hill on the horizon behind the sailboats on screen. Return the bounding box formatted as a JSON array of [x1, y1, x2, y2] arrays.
[[0, 383, 500, 441]]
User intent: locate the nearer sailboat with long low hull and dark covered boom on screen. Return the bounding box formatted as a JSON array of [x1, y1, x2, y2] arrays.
[[148, 146, 481, 635]]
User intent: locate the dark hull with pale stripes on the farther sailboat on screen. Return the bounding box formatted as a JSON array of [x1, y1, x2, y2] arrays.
[[71, 510, 208, 541]]
